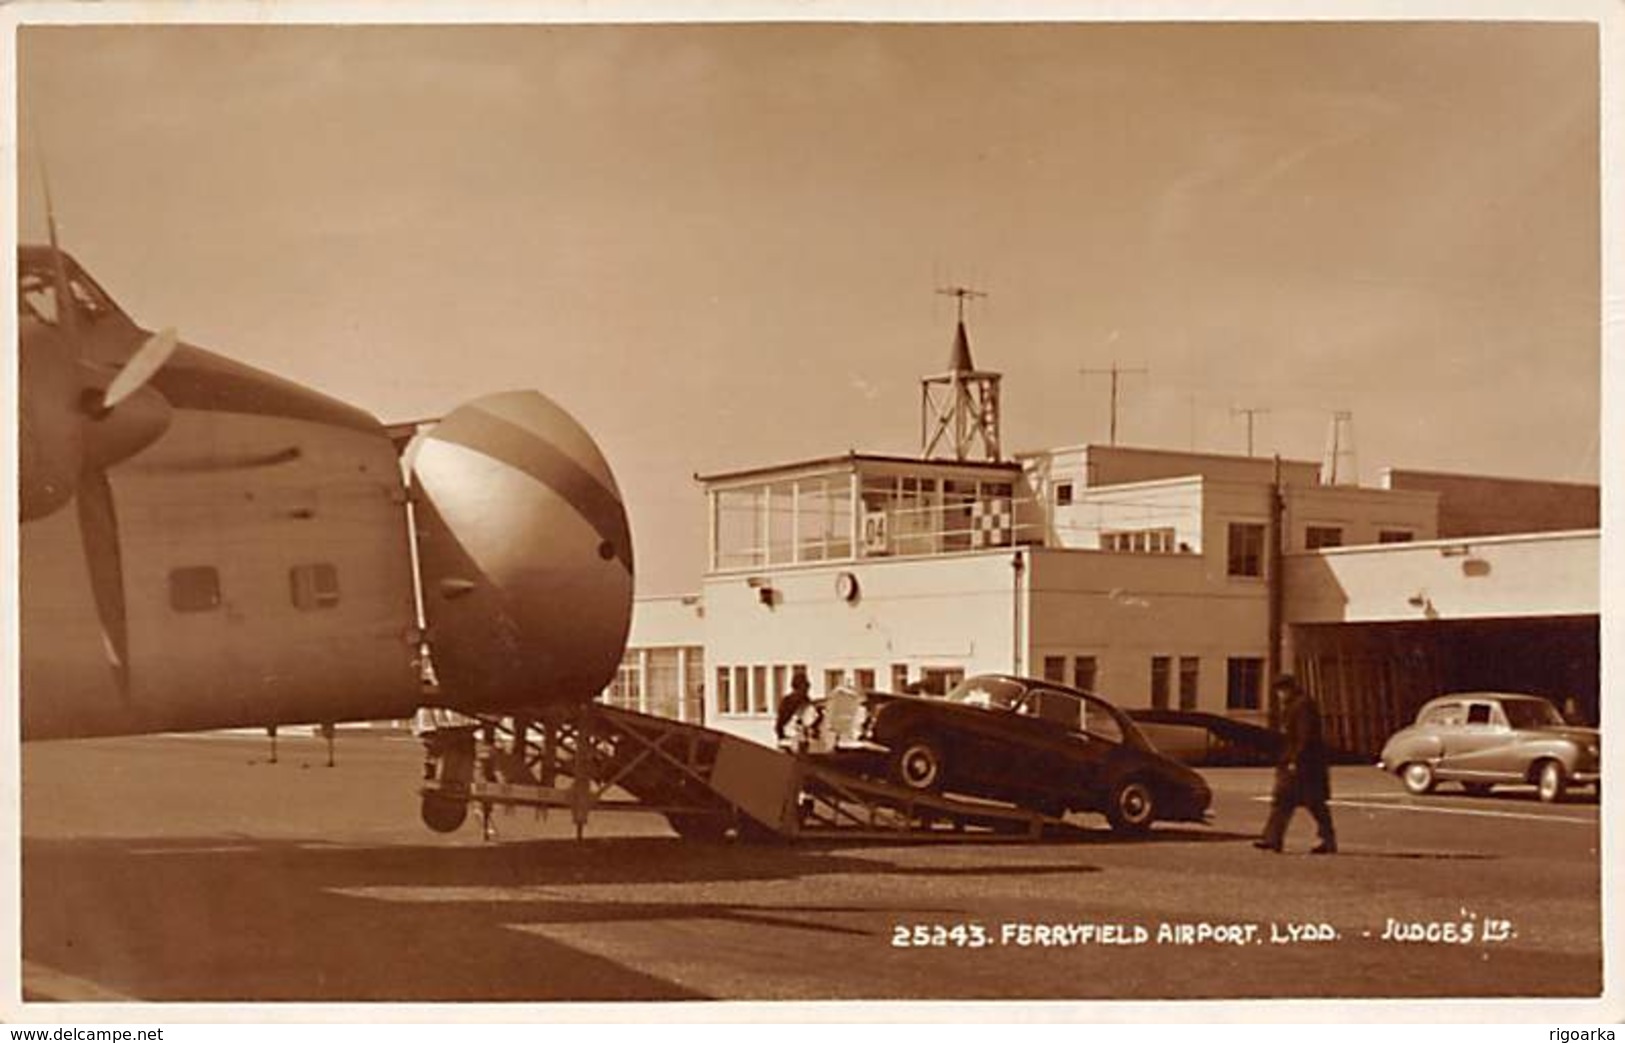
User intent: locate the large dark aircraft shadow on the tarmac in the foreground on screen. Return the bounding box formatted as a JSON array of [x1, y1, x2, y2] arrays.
[[23, 835, 1100, 1002]]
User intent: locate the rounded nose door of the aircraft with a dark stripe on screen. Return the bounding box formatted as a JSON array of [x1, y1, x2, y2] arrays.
[[406, 392, 632, 712]]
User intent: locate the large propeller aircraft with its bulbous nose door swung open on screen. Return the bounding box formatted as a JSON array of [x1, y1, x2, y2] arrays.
[[18, 209, 634, 741]]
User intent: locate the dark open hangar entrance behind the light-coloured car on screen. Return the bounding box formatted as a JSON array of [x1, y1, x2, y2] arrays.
[[1292, 616, 1602, 757]]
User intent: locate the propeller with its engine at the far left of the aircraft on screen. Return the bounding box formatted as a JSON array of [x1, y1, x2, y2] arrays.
[[18, 134, 177, 700]]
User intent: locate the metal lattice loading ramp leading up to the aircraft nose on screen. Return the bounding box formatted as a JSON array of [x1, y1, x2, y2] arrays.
[[419, 703, 1051, 842]]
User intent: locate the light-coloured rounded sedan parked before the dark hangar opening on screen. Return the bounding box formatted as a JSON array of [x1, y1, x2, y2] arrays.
[[1376, 692, 1602, 803]]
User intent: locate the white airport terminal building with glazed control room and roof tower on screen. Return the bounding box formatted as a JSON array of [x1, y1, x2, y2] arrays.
[[605, 323, 1601, 752]]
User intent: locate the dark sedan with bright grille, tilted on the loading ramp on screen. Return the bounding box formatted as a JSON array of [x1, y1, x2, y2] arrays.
[[806, 674, 1212, 833]]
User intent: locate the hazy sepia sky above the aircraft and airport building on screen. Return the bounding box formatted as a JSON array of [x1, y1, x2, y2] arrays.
[[18, 10, 1601, 595]]
